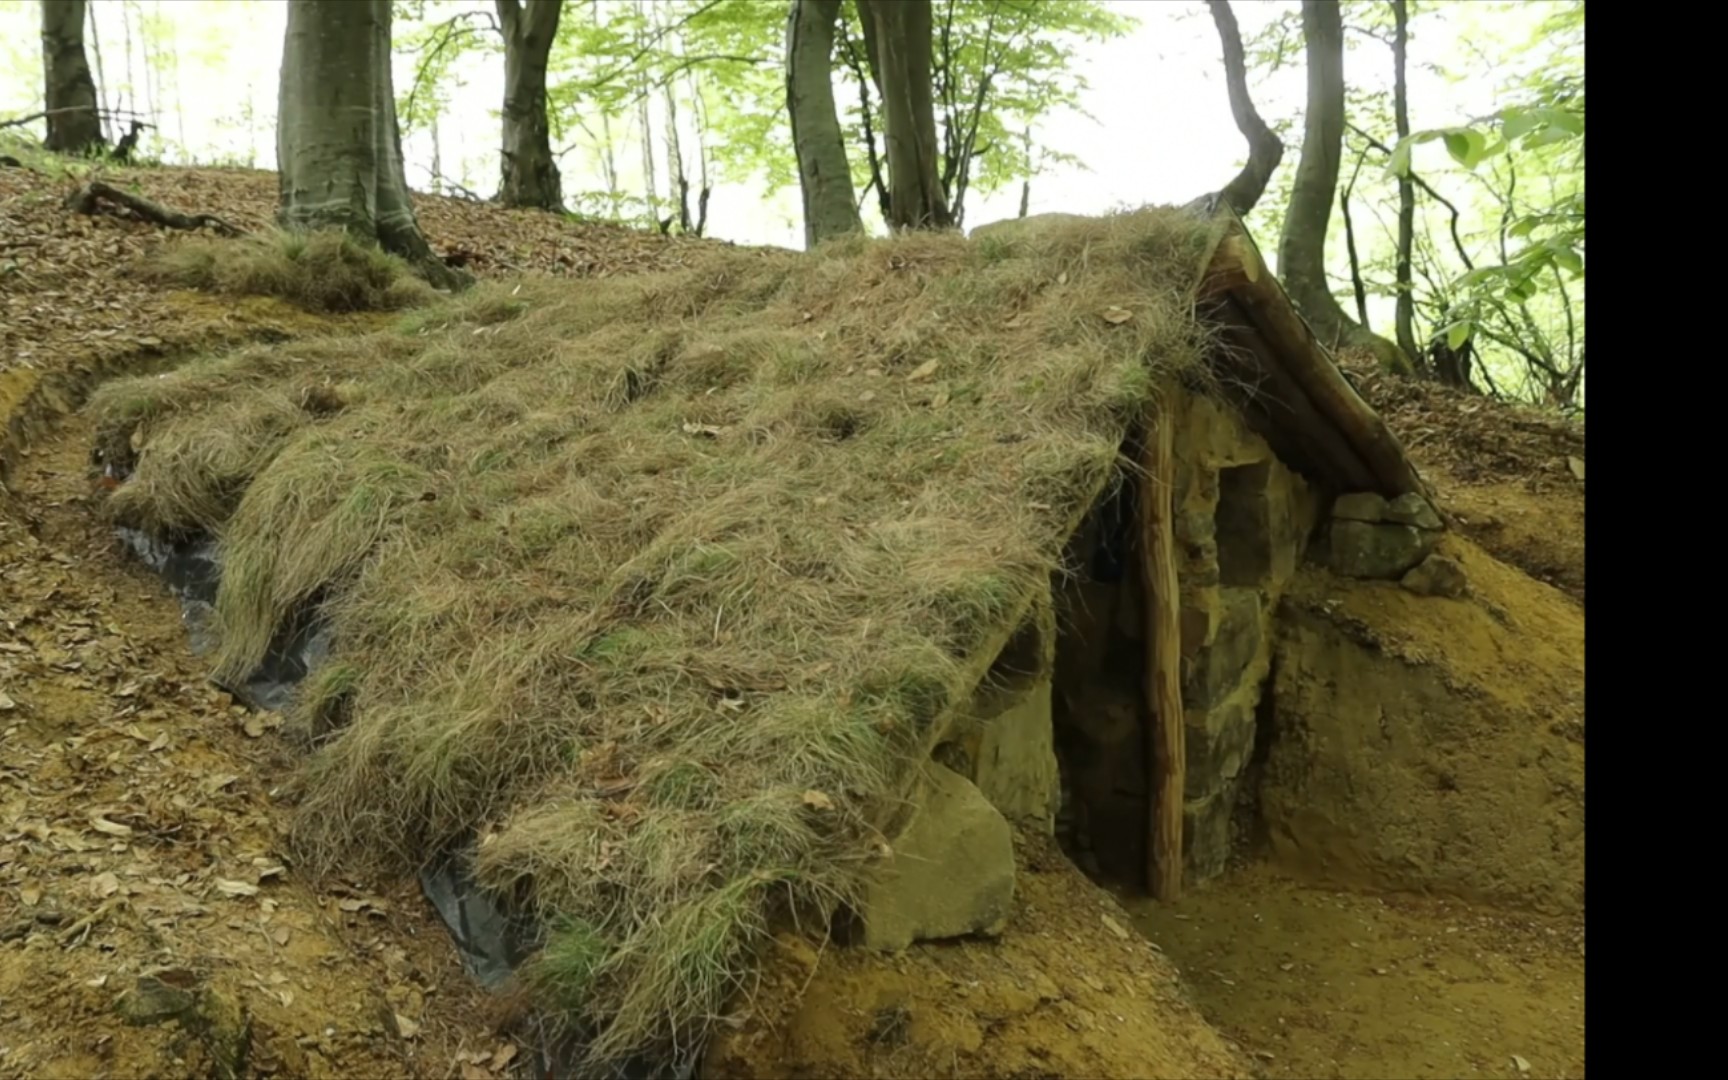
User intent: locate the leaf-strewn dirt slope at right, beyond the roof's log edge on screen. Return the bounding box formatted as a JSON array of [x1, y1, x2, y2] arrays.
[[1341, 356, 1585, 601]]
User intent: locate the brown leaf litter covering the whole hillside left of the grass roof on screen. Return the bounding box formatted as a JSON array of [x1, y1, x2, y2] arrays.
[[0, 155, 546, 1078]]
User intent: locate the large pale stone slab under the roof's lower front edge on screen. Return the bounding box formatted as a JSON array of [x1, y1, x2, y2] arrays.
[[859, 762, 1014, 952]]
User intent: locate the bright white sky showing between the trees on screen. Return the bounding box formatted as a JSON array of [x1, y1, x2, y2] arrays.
[[0, 0, 1540, 247]]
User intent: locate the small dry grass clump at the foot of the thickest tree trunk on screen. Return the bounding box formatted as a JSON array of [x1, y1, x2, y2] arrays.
[[152, 230, 437, 314]]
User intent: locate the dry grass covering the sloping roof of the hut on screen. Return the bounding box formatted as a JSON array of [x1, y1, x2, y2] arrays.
[[95, 211, 1206, 1059]]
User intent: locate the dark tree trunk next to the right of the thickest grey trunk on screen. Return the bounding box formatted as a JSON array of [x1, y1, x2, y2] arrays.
[[496, 0, 563, 211]]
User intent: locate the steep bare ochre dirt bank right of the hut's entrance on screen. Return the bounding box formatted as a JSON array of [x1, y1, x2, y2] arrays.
[[1260, 537, 1585, 912]]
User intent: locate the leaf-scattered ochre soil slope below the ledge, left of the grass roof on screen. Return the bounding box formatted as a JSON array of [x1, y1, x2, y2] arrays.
[[0, 427, 499, 1078]]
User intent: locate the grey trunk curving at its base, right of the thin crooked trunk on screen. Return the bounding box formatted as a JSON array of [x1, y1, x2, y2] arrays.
[[1279, 0, 1414, 375]]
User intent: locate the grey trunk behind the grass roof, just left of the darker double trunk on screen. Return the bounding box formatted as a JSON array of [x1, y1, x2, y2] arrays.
[[786, 0, 864, 247]]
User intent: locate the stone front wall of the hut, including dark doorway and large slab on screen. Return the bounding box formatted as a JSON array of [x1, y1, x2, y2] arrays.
[[859, 392, 1317, 950]]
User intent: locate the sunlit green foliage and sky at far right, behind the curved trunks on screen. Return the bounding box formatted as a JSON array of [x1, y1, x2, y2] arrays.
[[1244, 0, 1585, 403]]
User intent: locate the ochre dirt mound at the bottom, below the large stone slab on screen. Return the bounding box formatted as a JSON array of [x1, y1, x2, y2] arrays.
[[703, 836, 1251, 1080]]
